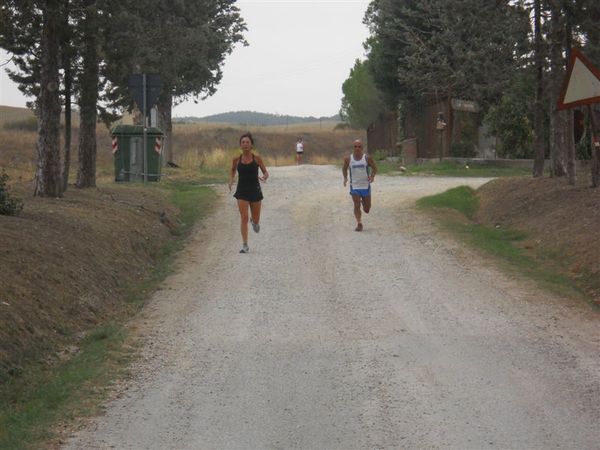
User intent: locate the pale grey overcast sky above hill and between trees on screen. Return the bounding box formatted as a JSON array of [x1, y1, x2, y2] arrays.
[[0, 0, 369, 117]]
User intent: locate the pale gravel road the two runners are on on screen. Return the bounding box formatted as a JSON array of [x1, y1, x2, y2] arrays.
[[67, 166, 600, 449]]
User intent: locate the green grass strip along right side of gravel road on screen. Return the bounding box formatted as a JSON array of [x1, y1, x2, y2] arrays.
[[417, 186, 582, 295]]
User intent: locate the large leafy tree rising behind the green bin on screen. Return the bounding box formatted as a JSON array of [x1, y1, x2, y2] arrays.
[[104, 0, 246, 161]]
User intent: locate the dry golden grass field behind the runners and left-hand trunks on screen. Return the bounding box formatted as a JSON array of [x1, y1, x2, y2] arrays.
[[0, 106, 366, 181]]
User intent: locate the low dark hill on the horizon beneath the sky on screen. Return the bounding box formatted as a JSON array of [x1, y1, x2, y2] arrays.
[[173, 111, 340, 126]]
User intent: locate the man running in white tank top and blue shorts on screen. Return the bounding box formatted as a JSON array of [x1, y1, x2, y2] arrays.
[[342, 139, 377, 231]]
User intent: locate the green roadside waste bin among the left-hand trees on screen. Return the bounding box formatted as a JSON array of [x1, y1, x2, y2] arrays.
[[111, 125, 164, 182]]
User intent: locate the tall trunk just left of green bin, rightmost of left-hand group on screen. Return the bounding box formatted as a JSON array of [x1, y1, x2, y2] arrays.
[[77, 4, 98, 188]]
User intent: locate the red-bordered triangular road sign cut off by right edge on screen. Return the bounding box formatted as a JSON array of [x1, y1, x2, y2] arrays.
[[556, 48, 600, 110]]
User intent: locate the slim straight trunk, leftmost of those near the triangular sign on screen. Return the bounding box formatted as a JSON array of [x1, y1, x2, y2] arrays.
[[533, 0, 546, 177]]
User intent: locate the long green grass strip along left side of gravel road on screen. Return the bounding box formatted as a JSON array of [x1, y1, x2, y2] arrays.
[[0, 182, 216, 450]]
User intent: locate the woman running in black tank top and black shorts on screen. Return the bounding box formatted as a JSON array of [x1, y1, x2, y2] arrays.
[[229, 133, 269, 253]]
